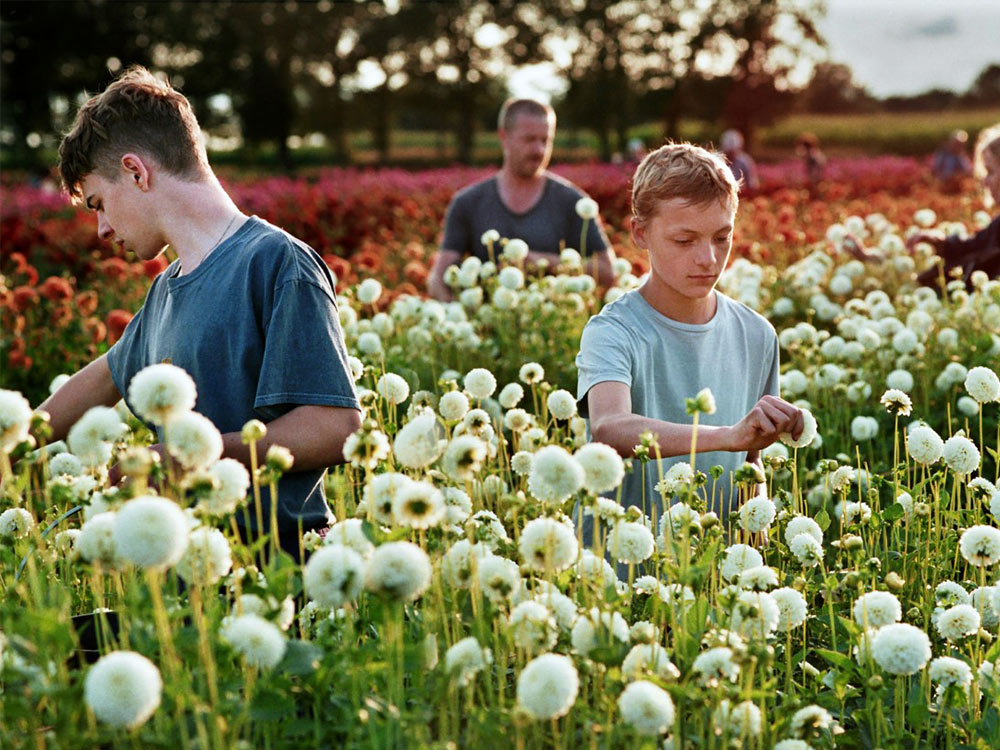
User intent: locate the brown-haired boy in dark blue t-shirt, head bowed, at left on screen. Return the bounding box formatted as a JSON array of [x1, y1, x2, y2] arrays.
[[41, 68, 361, 554]]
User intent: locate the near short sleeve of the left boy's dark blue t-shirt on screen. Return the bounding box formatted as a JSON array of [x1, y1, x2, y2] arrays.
[[254, 279, 360, 418]]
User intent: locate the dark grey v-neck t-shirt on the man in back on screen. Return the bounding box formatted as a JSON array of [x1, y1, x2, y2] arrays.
[[441, 173, 610, 261]]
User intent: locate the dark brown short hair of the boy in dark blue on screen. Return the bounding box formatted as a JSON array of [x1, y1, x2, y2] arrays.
[[59, 66, 209, 201]]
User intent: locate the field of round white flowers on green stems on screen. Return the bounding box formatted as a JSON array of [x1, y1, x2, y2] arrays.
[[0, 213, 1000, 750]]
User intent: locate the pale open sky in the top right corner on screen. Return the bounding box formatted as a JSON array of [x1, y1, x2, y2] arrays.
[[819, 0, 1000, 97]]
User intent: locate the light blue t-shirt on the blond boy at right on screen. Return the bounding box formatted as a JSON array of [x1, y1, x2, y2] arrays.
[[576, 290, 778, 518]]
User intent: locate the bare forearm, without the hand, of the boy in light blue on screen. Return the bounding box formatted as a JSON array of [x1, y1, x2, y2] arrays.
[[591, 414, 732, 458]]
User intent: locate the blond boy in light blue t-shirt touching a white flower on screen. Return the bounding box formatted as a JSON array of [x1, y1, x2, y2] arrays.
[[576, 144, 804, 536]]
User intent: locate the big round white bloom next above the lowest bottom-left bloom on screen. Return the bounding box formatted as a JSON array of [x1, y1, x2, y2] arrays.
[[112, 495, 189, 568]]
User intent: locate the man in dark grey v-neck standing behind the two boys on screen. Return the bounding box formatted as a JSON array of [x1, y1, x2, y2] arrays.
[[427, 99, 614, 300]]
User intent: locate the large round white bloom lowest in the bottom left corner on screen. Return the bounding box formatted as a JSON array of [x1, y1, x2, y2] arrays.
[[83, 651, 163, 729]]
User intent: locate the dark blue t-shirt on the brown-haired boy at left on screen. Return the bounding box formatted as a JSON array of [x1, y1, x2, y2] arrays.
[[108, 217, 359, 538]]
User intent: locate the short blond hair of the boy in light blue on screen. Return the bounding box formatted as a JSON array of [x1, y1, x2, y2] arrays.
[[632, 143, 739, 222]]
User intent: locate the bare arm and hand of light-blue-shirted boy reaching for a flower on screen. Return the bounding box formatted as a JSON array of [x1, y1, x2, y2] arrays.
[[587, 381, 802, 457]]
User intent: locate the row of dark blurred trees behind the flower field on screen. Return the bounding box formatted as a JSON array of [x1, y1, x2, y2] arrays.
[[0, 0, 1000, 170]]
